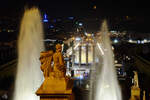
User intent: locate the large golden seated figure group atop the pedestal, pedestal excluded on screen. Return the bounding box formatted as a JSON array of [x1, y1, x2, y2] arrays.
[[40, 44, 66, 78]]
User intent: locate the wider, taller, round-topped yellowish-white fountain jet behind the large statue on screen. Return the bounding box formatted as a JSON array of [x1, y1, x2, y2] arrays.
[[13, 8, 44, 100]]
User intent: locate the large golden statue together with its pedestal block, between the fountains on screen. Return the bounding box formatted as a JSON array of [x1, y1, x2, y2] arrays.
[[36, 44, 73, 95]]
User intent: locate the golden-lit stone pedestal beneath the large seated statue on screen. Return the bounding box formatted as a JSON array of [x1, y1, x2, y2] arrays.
[[36, 77, 74, 100]]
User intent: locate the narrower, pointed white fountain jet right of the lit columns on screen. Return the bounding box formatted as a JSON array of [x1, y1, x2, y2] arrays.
[[92, 21, 122, 100]]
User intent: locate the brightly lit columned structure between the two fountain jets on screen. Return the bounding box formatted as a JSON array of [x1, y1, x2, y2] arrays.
[[67, 33, 95, 79]]
